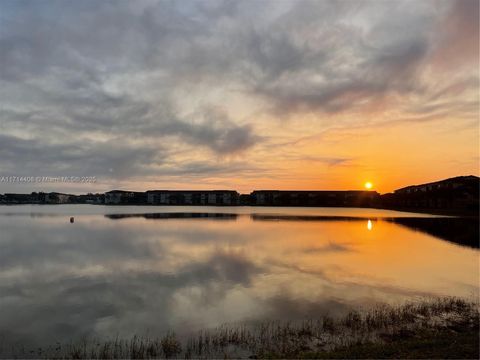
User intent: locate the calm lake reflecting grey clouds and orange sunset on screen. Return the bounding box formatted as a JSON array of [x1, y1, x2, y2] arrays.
[[0, 205, 479, 349]]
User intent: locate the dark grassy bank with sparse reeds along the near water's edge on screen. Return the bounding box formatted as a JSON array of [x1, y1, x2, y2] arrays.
[[4, 298, 479, 359]]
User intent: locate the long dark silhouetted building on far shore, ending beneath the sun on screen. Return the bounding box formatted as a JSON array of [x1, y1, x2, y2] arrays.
[[250, 190, 380, 207]]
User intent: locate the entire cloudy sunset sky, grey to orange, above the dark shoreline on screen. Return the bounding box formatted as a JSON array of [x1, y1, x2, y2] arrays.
[[0, 0, 480, 193]]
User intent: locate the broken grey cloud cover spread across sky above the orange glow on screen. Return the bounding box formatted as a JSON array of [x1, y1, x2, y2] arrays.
[[0, 0, 479, 191]]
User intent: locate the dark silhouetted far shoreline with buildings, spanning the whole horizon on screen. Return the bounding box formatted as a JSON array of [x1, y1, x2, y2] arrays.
[[0, 175, 480, 217]]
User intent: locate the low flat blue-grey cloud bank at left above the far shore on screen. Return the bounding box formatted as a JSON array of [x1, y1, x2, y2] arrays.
[[0, 135, 162, 178]]
